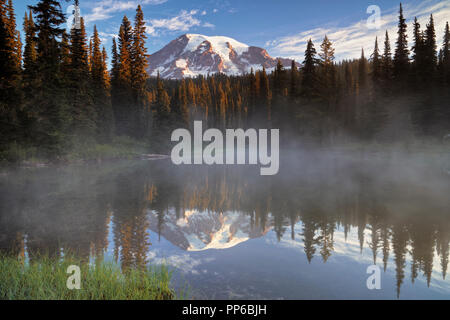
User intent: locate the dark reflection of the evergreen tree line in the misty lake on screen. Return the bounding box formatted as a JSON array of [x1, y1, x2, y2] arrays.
[[0, 154, 450, 295]]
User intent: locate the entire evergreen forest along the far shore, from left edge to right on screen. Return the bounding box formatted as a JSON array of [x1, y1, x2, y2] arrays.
[[0, 0, 450, 158]]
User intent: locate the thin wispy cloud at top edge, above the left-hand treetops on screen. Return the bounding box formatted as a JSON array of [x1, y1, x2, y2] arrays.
[[84, 0, 167, 23]]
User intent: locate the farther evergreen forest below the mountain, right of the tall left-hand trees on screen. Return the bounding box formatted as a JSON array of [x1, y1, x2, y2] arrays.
[[152, 5, 450, 148]]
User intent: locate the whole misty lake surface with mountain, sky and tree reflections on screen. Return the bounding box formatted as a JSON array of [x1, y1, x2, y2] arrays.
[[0, 152, 450, 299]]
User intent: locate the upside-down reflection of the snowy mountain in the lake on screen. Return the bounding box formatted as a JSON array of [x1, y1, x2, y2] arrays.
[[148, 210, 269, 251]]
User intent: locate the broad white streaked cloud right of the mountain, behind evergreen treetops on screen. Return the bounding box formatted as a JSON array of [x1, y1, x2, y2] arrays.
[[266, 0, 450, 61]]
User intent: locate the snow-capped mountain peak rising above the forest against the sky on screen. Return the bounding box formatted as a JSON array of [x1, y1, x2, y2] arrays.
[[148, 34, 298, 79]]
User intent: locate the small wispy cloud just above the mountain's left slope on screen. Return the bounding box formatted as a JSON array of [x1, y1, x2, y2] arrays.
[[147, 10, 214, 36]]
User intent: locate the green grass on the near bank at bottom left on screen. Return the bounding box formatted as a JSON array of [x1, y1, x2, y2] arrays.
[[0, 256, 184, 300]]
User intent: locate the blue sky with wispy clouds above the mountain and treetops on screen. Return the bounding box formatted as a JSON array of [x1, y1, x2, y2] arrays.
[[13, 0, 450, 61]]
